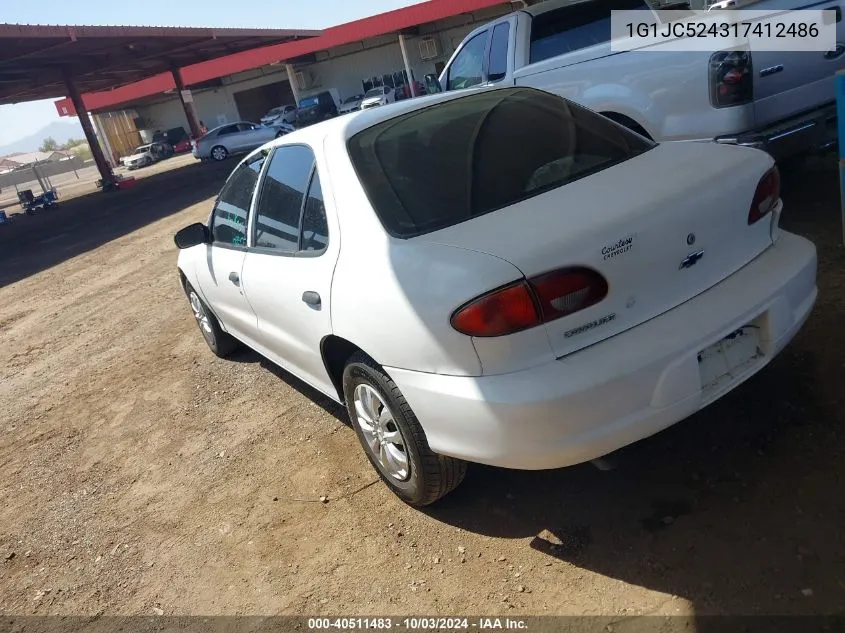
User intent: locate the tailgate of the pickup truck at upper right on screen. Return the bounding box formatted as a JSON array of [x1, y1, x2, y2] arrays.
[[751, 0, 845, 127]]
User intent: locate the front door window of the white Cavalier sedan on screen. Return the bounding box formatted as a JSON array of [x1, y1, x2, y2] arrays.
[[211, 154, 265, 247]]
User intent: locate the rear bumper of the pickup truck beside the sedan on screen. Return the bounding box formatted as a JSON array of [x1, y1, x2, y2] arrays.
[[715, 103, 837, 159]]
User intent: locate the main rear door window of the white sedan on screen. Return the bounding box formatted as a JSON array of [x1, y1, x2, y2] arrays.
[[253, 145, 314, 253]]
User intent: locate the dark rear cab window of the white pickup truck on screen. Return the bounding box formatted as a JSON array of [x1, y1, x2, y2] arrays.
[[530, 0, 648, 64]]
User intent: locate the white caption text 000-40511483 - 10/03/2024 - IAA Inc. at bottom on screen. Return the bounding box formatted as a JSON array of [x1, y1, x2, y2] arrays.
[[308, 617, 528, 631]]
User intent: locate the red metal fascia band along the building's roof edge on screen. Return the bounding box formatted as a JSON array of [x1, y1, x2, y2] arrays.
[[56, 0, 516, 115]]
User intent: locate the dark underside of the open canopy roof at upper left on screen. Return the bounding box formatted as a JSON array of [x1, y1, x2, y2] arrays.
[[0, 24, 321, 104]]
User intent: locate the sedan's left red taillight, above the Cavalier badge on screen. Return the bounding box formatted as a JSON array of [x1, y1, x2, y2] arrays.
[[451, 267, 608, 337]]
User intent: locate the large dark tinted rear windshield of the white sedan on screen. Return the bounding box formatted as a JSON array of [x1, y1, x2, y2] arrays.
[[348, 88, 654, 238]]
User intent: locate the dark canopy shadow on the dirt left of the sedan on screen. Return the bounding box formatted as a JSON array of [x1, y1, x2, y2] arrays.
[[0, 161, 234, 287]]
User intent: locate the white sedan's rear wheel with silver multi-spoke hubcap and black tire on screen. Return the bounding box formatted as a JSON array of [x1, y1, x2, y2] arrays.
[[343, 353, 467, 507]]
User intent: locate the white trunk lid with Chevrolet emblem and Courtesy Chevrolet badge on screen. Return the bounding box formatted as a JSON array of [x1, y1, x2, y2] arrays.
[[416, 143, 773, 357]]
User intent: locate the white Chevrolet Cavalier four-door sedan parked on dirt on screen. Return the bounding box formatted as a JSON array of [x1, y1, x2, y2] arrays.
[[176, 87, 817, 505]]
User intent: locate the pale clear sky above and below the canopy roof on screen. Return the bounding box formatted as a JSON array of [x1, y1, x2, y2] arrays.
[[0, 0, 421, 145]]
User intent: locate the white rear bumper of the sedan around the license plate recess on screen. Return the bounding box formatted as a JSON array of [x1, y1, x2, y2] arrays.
[[385, 232, 817, 470]]
